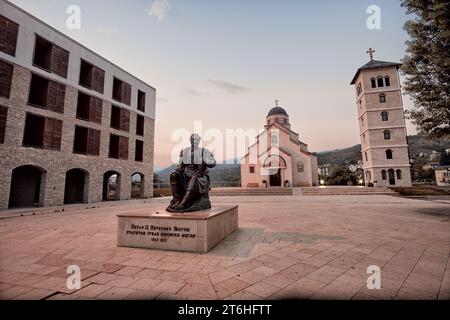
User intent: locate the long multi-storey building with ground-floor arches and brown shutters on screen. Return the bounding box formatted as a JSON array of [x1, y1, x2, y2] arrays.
[[0, 0, 156, 209]]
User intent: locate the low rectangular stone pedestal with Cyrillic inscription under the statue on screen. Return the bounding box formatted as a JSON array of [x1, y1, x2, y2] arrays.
[[117, 206, 238, 253]]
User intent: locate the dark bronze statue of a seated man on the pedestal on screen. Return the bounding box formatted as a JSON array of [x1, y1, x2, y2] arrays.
[[166, 134, 216, 213]]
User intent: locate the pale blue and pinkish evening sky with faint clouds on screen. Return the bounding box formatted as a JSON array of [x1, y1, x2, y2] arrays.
[[12, 0, 416, 169]]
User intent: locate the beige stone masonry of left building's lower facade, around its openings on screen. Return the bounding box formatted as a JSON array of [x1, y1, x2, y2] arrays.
[[0, 64, 155, 209]]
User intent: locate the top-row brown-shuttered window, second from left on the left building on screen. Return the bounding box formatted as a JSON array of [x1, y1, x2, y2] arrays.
[[33, 35, 69, 78]]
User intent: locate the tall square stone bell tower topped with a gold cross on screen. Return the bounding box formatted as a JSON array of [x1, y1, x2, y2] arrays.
[[351, 48, 412, 187]]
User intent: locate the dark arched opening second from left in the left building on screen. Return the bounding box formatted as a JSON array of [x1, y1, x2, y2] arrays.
[[64, 169, 89, 204]]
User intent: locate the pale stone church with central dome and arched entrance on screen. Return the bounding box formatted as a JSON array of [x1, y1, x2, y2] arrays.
[[241, 106, 318, 188]]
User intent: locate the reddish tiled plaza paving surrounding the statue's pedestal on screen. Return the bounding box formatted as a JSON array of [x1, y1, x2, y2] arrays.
[[0, 196, 450, 300]]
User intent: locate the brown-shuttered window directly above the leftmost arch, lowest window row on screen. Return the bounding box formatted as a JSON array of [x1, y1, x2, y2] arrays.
[[23, 113, 63, 151]]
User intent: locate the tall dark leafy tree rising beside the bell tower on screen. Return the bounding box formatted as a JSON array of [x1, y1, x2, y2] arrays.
[[402, 0, 450, 137]]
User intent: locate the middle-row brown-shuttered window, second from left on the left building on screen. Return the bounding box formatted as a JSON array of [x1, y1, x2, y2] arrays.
[[28, 74, 66, 113]]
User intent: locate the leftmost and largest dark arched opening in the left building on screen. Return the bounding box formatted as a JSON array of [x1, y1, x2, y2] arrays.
[[9, 166, 45, 208]]
